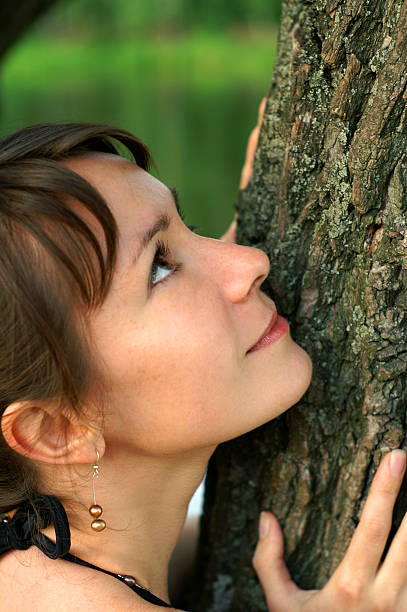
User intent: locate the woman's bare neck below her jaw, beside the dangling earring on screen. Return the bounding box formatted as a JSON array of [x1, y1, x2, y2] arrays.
[[45, 448, 214, 601]]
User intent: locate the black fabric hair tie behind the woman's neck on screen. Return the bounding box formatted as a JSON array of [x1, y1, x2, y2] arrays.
[[0, 495, 71, 559]]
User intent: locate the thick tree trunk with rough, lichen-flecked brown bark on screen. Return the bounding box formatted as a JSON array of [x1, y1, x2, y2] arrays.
[[188, 0, 407, 612]]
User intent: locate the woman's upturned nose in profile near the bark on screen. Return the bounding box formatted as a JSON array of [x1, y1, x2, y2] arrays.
[[209, 240, 270, 303]]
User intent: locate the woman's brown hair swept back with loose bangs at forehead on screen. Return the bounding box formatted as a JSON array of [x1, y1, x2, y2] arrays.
[[0, 123, 150, 512]]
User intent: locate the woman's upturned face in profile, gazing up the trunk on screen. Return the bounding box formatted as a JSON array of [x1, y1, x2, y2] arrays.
[[68, 154, 311, 454]]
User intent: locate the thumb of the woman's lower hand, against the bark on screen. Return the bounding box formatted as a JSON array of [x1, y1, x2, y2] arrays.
[[253, 512, 301, 612]]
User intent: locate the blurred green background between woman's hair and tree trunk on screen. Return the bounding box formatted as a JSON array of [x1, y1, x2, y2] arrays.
[[0, 0, 280, 237]]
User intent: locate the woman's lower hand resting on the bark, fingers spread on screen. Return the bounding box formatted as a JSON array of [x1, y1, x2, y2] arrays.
[[253, 450, 407, 612]]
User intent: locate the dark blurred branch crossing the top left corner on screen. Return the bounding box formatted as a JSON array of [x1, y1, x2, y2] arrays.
[[0, 0, 56, 59]]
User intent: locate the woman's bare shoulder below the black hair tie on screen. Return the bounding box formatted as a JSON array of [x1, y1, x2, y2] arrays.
[[0, 547, 182, 612]]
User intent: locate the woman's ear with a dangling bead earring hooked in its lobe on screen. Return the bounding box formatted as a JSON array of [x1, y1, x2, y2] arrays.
[[1, 400, 105, 464]]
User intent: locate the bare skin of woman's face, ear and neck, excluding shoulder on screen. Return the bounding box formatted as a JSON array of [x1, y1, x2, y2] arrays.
[[2, 107, 311, 603]]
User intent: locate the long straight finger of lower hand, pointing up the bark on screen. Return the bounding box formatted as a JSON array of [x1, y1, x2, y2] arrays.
[[340, 450, 406, 583]]
